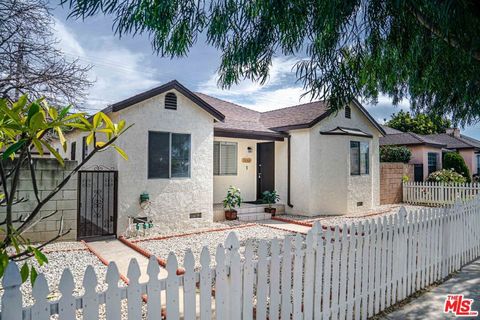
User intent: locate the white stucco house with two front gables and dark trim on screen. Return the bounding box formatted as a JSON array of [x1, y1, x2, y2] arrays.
[[55, 81, 384, 240]]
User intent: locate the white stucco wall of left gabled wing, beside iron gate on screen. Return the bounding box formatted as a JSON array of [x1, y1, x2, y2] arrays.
[[54, 90, 214, 235]]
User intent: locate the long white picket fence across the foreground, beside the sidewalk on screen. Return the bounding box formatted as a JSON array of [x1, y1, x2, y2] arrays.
[[1, 198, 480, 320]]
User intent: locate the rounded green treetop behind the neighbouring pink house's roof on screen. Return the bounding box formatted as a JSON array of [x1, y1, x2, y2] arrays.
[[385, 110, 452, 134]]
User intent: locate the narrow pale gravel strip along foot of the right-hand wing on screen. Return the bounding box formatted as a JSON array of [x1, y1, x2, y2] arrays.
[[278, 205, 429, 226]]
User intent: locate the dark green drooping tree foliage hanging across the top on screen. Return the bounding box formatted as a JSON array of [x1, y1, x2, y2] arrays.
[[62, 0, 480, 124]]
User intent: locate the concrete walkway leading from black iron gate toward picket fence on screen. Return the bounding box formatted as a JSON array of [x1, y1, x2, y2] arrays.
[[88, 239, 167, 282]]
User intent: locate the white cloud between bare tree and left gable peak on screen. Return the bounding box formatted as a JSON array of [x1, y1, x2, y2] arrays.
[[55, 19, 161, 111]]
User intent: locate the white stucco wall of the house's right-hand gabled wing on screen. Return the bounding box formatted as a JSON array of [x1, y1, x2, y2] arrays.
[[287, 104, 380, 216]]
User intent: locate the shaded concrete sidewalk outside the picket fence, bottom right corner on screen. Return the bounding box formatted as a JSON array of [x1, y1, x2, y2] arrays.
[[383, 259, 480, 320]]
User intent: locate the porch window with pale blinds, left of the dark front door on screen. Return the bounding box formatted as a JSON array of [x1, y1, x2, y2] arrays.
[[213, 141, 237, 176]]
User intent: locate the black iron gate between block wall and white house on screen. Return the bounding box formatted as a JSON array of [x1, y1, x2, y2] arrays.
[[77, 170, 118, 240]]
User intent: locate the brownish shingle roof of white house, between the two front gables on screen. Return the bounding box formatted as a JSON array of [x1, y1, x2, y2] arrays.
[[196, 93, 385, 136]]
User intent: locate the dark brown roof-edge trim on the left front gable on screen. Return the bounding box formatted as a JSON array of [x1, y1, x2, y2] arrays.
[[102, 80, 225, 121]]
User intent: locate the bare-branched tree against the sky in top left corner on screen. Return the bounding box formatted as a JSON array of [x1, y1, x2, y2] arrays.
[[0, 0, 91, 105]]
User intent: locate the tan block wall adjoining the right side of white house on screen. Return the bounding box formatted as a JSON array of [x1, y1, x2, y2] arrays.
[[380, 162, 413, 204]]
